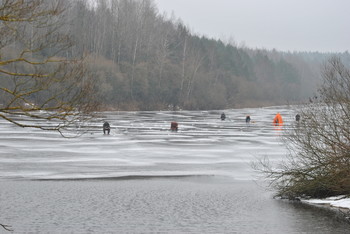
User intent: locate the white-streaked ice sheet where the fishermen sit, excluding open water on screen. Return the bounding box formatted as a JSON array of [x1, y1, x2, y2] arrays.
[[0, 107, 295, 179]]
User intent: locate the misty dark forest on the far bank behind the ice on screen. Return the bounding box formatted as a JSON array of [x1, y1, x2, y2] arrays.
[[50, 0, 350, 110]]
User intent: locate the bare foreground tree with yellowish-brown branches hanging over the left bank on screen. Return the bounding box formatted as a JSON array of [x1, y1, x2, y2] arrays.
[[0, 0, 94, 131]]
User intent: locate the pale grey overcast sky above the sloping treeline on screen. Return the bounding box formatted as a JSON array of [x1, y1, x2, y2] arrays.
[[154, 0, 350, 52]]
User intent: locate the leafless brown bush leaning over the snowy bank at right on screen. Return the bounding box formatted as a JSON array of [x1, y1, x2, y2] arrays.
[[259, 57, 350, 198]]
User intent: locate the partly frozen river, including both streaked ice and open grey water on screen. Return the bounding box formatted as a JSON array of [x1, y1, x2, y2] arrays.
[[0, 107, 350, 233]]
